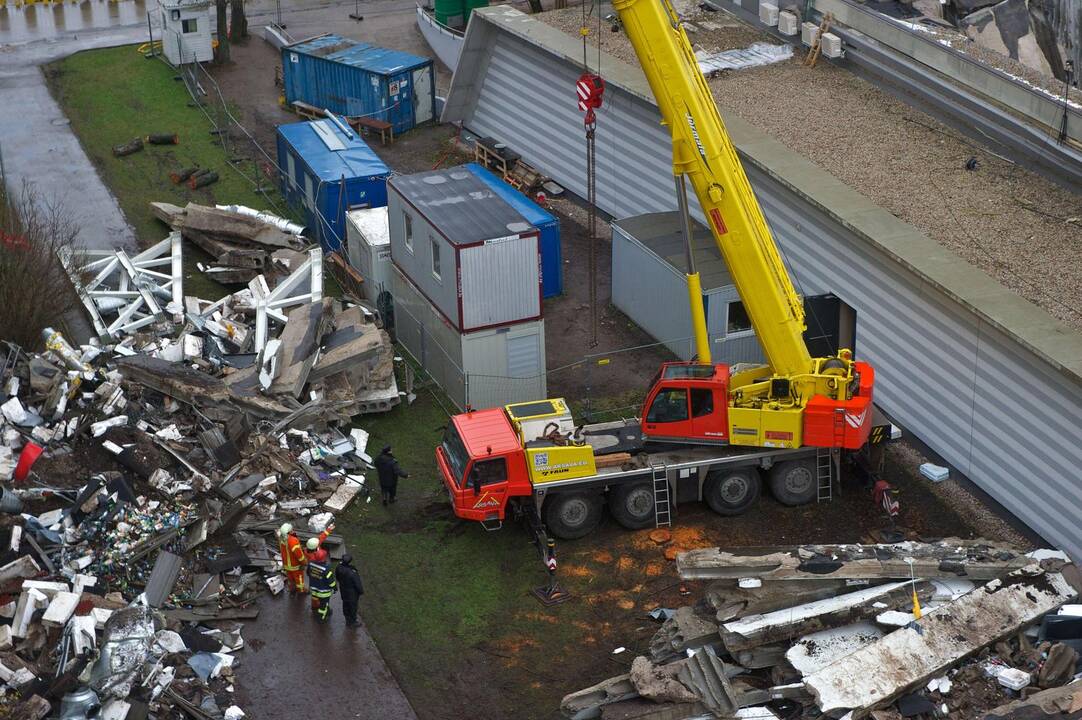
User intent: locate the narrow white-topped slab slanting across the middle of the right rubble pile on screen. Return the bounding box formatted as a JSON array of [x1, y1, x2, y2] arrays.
[[721, 582, 933, 652]]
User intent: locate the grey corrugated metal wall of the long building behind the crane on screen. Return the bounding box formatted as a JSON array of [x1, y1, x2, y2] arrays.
[[448, 11, 1082, 559]]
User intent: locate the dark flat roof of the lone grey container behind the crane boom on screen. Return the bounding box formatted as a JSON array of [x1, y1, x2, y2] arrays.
[[612, 210, 733, 292]]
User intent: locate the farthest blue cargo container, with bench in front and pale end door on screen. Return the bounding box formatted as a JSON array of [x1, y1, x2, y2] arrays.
[[281, 35, 436, 133]]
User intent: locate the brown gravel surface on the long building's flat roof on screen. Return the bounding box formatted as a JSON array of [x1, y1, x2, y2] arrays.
[[539, 9, 1082, 329]]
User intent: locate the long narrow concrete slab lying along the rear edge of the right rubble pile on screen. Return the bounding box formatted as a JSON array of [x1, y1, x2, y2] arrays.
[[676, 538, 1031, 580]]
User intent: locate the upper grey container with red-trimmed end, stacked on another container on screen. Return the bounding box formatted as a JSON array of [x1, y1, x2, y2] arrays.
[[387, 168, 542, 332]]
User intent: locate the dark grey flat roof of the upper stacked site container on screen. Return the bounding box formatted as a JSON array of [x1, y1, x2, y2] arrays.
[[387, 167, 532, 246]]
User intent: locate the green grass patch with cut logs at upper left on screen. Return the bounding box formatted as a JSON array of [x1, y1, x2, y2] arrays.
[[44, 45, 286, 299]]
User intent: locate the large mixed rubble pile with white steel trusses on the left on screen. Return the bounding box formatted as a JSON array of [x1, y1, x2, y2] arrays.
[[0, 209, 399, 720]]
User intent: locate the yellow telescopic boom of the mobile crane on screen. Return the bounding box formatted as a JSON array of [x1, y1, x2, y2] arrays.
[[612, 0, 816, 376]]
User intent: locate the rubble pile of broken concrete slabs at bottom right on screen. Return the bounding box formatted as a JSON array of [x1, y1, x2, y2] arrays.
[[560, 538, 1082, 720]]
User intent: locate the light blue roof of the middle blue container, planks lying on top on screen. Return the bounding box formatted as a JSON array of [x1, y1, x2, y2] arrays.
[[278, 119, 391, 182]]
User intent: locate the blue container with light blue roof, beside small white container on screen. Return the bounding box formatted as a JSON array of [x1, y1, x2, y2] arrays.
[[277, 118, 391, 250]]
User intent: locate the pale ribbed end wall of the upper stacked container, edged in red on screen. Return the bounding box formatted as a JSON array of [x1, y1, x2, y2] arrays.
[[459, 234, 541, 330]]
